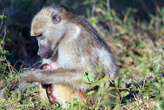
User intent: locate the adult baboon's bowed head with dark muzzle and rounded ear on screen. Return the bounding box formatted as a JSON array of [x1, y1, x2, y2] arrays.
[[31, 9, 65, 58]]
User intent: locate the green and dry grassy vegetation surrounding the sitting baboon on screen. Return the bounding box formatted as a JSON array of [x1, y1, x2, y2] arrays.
[[0, 0, 164, 110]]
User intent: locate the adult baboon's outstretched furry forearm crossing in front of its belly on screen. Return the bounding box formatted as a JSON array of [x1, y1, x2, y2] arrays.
[[23, 69, 90, 90]]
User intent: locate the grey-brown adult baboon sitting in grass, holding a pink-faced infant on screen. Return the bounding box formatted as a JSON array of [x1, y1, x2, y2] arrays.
[[0, 6, 119, 107]]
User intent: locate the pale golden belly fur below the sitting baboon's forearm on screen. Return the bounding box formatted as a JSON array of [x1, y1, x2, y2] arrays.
[[38, 84, 86, 107]]
